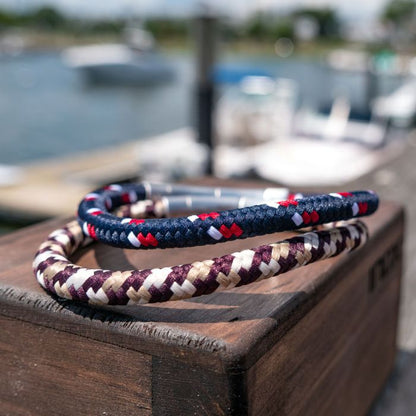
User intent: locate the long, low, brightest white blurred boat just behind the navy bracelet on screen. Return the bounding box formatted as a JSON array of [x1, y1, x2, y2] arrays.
[[214, 133, 405, 188]]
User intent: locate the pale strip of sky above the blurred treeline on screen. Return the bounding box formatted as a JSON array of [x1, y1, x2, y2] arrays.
[[4, 0, 387, 19]]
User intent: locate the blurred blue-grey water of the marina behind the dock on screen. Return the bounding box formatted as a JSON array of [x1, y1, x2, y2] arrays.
[[0, 53, 404, 164]]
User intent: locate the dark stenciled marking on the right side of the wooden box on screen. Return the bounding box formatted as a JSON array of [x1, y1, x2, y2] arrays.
[[368, 241, 402, 293]]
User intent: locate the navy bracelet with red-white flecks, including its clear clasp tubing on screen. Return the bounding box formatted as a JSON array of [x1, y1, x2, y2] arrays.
[[78, 183, 378, 249]]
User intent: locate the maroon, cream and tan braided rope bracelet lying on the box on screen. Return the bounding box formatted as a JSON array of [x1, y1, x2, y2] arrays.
[[33, 221, 367, 305]]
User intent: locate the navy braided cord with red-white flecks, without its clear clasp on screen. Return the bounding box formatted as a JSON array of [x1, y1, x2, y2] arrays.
[[78, 184, 378, 249]]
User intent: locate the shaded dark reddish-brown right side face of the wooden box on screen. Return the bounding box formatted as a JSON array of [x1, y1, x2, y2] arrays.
[[247, 229, 401, 416]]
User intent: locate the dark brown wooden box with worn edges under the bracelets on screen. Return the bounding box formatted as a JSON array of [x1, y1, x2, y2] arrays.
[[0, 203, 403, 416]]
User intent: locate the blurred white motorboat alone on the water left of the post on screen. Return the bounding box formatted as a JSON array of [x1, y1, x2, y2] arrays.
[[62, 29, 175, 85]]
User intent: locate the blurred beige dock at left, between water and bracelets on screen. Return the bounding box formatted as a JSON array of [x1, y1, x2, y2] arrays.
[[0, 128, 192, 223]]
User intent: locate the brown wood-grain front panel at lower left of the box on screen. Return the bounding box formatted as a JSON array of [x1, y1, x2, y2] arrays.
[[0, 317, 151, 416]]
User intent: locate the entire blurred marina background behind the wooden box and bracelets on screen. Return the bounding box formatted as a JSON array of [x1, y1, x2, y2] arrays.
[[0, 0, 416, 415]]
